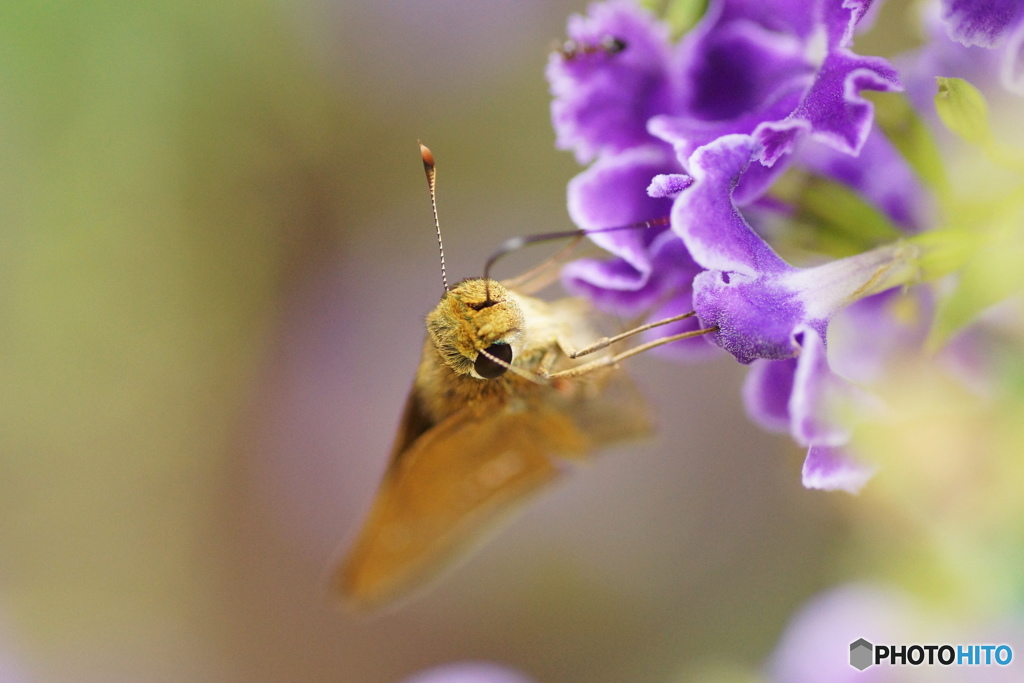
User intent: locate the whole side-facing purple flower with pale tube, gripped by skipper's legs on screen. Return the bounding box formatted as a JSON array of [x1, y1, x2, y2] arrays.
[[672, 135, 916, 493]]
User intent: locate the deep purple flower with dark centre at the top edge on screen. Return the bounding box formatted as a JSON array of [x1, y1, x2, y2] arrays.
[[649, 0, 900, 171]]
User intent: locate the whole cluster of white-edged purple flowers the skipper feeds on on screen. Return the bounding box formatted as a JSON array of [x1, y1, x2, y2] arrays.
[[548, 0, 1024, 492]]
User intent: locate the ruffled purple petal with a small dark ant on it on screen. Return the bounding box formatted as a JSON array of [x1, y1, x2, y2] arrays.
[[547, 2, 673, 164]]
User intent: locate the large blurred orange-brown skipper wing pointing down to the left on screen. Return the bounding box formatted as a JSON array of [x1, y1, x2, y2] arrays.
[[336, 405, 592, 608]]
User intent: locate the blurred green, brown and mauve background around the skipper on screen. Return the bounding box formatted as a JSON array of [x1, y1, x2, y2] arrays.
[[0, 0, 954, 683]]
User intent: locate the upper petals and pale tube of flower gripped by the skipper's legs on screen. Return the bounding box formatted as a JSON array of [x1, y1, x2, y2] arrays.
[[672, 135, 915, 364]]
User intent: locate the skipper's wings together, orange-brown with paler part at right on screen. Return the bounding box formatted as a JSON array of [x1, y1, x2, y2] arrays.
[[335, 311, 651, 608]]
